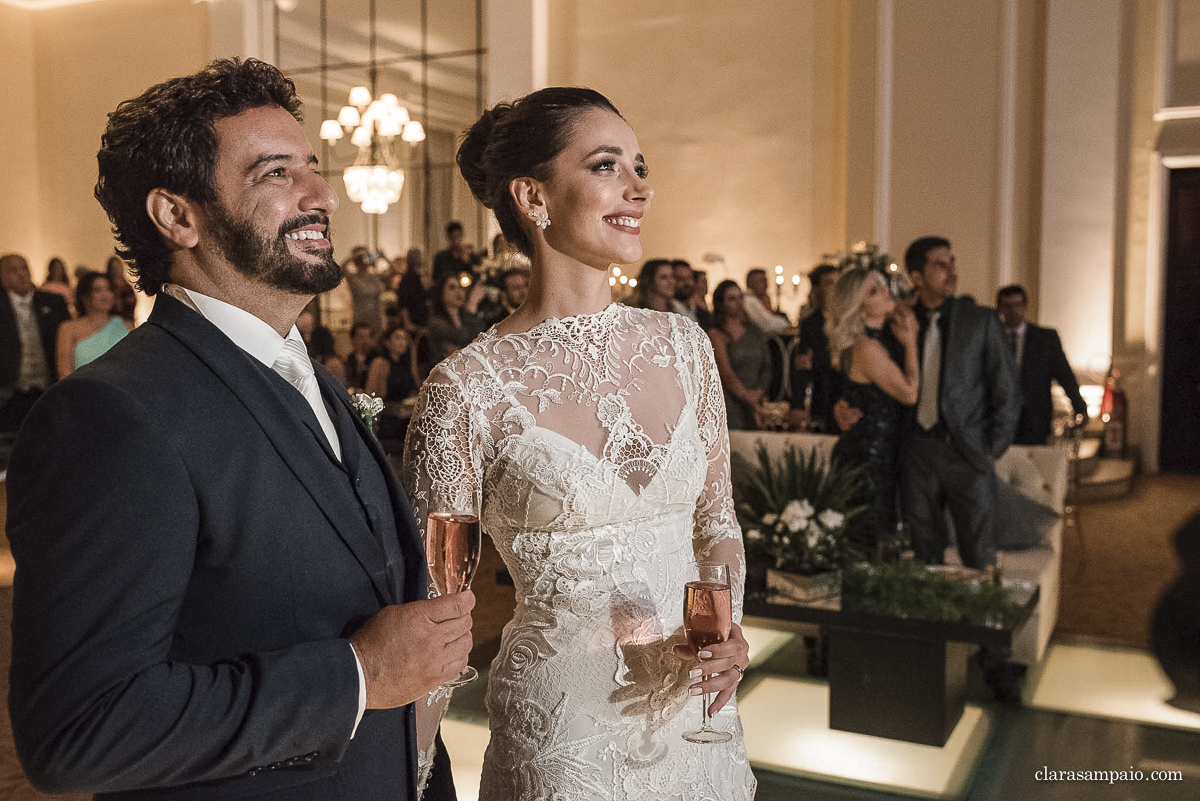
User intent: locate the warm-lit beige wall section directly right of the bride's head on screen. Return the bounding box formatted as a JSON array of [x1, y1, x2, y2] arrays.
[[547, 0, 846, 311]]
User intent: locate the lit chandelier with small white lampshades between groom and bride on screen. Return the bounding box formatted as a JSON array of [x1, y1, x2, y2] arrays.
[[320, 88, 425, 215]]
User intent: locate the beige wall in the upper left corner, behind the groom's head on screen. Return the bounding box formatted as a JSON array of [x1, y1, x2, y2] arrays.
[[0, 0, 209, 287]]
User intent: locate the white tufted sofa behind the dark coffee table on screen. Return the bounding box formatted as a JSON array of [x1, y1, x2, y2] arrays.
[[730, 432, 1068, 666]]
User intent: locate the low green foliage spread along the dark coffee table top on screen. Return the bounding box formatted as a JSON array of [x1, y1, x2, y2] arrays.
[[841, 560, 1030, 628]]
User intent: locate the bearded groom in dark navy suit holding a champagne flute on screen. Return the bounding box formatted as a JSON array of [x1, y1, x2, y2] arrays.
[[8, 60, 474, 801]]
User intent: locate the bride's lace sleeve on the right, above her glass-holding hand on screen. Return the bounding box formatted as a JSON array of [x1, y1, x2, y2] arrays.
[[689, 326, 745, 621]]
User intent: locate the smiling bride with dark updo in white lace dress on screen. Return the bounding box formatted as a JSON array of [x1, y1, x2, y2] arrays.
[[404, 88, 755, 801]]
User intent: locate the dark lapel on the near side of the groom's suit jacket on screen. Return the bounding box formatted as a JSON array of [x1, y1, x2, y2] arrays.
[[146, 295, 392, 601]]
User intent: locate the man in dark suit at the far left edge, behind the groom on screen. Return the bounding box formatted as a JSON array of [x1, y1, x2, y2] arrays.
[[0, 253, 71, 433]]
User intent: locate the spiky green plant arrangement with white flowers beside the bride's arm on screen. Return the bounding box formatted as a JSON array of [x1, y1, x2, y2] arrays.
[[734, 445, 865, 573]]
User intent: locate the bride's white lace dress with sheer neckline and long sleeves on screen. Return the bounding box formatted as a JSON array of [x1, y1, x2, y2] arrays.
[[404, 303, 755, 801]]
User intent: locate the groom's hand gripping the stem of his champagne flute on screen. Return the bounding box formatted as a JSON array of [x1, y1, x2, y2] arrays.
[[350, 590, 475, 709]]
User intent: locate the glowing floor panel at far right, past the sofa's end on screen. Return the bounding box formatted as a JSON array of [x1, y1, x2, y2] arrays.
[[1025, 644, 1200, 730]]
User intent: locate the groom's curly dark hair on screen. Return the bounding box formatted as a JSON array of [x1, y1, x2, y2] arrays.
[[95, 59, 304, 295]]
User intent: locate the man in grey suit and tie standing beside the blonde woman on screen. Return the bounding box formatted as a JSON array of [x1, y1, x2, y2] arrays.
[[901, 236, 1021, 568]]
